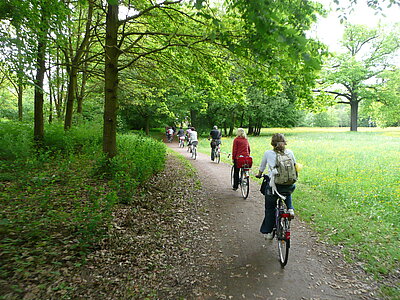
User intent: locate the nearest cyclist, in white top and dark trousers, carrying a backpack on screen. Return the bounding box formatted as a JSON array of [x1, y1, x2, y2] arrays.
[[256, 133, 296, 240]]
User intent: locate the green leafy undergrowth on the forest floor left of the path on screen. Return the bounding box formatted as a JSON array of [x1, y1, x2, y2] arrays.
[[0, 122, 166, 294]]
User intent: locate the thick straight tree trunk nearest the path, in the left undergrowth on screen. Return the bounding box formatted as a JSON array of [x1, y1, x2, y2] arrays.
[[103, 4, 119, 158]]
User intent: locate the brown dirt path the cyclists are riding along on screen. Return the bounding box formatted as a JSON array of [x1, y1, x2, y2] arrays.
[[168, 143, 379, 300]]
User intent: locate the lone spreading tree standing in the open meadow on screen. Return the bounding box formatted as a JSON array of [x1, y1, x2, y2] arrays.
[[314, 24, 400, 131]]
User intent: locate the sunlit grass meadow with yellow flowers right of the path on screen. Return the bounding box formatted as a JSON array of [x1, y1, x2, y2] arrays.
[[195, 128, 400, 297]]
